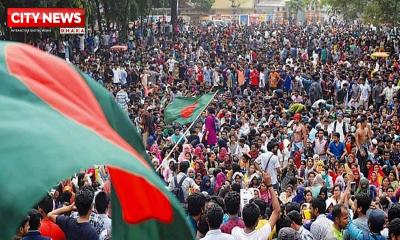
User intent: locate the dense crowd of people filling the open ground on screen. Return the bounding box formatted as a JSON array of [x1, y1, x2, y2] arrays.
[[14, 19, 400, 240]]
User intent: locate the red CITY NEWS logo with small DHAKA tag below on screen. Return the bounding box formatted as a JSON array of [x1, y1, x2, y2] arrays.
[[7, 8, 85, 34]]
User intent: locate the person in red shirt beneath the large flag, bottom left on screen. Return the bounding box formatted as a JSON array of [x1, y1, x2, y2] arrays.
[[38, 195, 66, 240]]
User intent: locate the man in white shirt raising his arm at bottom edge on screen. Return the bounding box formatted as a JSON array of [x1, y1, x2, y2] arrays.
[[232, 173, 280, 240]]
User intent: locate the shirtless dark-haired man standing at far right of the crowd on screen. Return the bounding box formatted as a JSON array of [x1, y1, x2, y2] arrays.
[[356, 115, 372, 176]]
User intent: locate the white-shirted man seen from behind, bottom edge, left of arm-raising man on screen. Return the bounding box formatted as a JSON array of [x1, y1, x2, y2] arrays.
[[202, 203, 234, 240]]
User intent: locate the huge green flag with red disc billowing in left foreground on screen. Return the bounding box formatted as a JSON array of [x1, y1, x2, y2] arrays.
[[0, 42, 193, 240]]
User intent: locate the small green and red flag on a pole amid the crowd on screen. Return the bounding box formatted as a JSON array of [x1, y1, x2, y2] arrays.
[[164, 93, 215, 124]]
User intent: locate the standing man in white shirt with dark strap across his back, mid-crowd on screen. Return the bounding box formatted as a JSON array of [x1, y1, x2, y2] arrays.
[[254, 141, 281, 189]]
